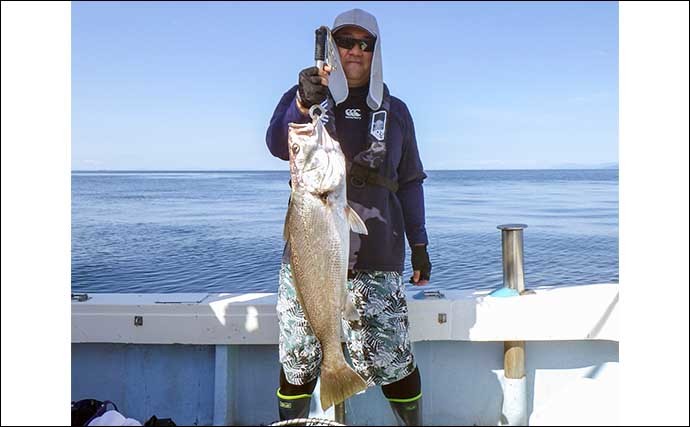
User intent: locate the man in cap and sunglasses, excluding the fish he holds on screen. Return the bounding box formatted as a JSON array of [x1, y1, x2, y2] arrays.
[[266, 9, 431, 425]]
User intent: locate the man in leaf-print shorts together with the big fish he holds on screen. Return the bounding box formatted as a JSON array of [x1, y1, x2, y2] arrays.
[[266, 9, 431, 425]]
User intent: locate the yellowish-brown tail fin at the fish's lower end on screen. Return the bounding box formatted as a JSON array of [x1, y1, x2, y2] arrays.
[[320, 358, 367, 411]]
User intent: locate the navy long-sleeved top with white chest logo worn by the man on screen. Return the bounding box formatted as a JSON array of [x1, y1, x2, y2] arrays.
[[266, 86, 428, 273]]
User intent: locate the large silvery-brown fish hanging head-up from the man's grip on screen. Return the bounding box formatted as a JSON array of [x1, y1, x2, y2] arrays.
[[284, 108, 367, 410]]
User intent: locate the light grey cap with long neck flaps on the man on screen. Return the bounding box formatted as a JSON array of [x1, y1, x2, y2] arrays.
[[328, 9, 383, 110]]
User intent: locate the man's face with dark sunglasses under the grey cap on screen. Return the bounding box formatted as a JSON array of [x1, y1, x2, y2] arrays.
[[333, 26, 374, 87]]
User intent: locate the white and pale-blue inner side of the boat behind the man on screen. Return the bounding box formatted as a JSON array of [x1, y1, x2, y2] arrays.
[[72, 284, 619, 425]]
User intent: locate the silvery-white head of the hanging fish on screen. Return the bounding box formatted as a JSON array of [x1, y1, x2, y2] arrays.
[[288, 123, 345, 197]]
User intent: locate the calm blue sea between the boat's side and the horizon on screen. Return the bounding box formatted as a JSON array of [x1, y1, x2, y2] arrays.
[[72, 170, 618, 293]]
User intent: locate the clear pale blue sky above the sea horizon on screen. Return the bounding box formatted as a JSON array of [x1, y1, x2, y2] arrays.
[[71, 2, 619, 170]]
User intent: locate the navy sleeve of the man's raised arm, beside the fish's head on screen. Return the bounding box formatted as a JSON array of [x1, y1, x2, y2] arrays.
[[266, 85, 309, 160]]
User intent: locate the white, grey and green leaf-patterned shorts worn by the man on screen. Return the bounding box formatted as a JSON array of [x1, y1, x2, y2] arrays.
[[277, 263, 415, 386]]
